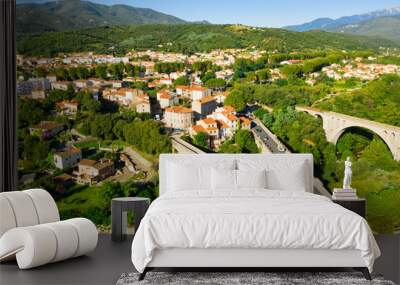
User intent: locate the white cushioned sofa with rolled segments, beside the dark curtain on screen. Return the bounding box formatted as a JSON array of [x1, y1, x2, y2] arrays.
[[0, 189, 98, 269]]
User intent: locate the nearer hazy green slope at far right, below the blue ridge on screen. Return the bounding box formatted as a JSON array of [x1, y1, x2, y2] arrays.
[[330, 16, 400, 41]]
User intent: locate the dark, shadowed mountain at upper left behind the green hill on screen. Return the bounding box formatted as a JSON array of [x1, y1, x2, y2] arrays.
[[16, 0, 185, 34]]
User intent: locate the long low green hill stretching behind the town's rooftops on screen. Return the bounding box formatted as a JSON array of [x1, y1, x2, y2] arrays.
[[17, 24, 397, 56]]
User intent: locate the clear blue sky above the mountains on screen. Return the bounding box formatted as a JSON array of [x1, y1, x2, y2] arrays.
[[17, 0, 400, 27]]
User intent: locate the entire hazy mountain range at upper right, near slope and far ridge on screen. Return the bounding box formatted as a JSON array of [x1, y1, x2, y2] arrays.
[[284, 7, 400, 41]]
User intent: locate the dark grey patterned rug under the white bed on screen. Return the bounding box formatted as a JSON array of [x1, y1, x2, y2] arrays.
[[117, 272, 395, 285]]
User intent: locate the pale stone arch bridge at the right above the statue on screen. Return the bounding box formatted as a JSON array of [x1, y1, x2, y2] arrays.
[[296, 106, 400, 160]]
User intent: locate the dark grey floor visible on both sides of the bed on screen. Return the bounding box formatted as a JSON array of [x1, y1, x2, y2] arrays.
[[0, 234, 400, 285]]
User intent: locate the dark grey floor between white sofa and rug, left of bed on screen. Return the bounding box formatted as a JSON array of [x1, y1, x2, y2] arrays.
[[0, 234, 134, 285]]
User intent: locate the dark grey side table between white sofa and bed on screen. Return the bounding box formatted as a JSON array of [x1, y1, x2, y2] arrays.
[[111, 197, 150, 241]]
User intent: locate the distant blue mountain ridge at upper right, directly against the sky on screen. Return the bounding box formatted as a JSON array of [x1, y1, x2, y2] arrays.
[[284, 7, 400, 32]]
